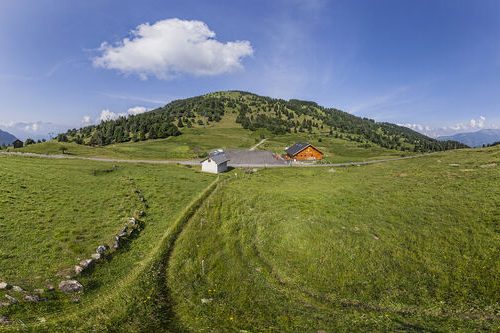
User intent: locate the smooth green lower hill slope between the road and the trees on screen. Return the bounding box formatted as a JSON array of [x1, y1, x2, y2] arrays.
[[11, 113, 412, 163]]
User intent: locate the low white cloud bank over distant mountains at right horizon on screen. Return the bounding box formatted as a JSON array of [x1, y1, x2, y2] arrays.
[[398, 116, 500, 137]]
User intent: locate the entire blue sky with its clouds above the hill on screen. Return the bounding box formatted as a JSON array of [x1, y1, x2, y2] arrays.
[[0, 0, 500, 137]]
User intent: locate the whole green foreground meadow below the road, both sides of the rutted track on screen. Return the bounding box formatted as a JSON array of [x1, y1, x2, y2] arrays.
[[0, 148, 500, 332]]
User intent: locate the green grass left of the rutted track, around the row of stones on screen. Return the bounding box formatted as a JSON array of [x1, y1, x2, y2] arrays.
[[0, 156, 215, 331]]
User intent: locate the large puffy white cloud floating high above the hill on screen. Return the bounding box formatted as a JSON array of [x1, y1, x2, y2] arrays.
[[93, 18, 253, 79]]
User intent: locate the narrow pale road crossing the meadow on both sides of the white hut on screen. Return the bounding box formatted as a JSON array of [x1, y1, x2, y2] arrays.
[[0, 151, 432, 168]]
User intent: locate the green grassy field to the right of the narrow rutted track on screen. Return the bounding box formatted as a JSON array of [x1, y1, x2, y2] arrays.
[[168, 149, 500, 332]]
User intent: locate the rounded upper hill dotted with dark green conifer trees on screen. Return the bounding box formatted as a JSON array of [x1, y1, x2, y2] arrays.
[[58, 91, 467, 152]]
